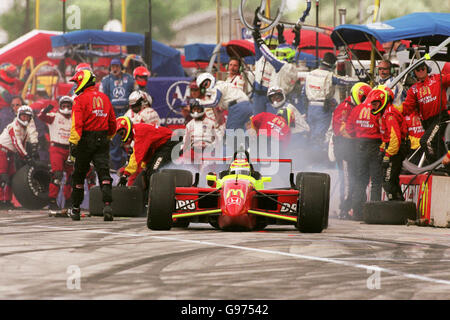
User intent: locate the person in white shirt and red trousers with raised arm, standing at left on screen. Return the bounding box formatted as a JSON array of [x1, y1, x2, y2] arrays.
[[37, 96, 73, 210]]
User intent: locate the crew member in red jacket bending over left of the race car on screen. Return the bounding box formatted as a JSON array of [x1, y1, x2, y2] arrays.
[[117, 116, 179, 187]]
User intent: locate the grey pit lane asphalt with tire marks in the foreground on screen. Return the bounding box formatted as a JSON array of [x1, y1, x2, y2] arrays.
[[0, 210, 450, 300]]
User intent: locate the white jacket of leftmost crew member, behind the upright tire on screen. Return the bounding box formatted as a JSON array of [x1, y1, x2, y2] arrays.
[[0, 117, 38, 158]]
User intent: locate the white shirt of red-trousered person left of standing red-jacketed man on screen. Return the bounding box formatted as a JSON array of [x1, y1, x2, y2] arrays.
[[38, 111, 72, 145]]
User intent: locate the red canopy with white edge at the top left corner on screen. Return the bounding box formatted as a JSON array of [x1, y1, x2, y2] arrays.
[[0, 30, 60, 66]]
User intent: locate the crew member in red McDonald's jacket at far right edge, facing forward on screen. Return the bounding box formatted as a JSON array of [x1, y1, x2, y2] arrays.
[[403, 62, 450, 162]]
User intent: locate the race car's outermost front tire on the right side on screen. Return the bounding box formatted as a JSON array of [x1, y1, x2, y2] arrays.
[[295, 172, 330, 233]]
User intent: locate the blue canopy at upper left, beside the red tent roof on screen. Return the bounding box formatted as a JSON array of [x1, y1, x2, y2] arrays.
[[51, 30, 184, 77]]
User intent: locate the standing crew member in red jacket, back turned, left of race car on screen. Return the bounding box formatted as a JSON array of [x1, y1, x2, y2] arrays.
[[69, 70, 116, 221]]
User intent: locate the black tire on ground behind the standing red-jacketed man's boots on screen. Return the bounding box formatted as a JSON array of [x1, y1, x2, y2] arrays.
[[89, 186, 144, 217]]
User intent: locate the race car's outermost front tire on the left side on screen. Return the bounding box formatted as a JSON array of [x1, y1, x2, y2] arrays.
[[147, 172, 176, 230]]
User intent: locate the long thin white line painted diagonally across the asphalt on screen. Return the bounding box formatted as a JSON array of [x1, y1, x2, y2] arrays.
[[34, 225, 450, 285]]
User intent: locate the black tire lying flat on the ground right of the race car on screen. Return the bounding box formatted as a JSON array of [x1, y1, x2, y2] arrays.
[[363, 201, 417, 225]]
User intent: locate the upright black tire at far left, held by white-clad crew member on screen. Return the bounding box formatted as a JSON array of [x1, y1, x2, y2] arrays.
[[11, 163, 51, 210]]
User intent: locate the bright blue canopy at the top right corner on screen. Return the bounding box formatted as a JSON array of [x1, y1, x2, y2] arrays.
[[331, 12, 450, 47]]
